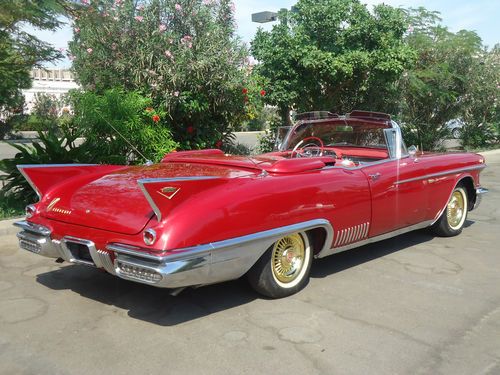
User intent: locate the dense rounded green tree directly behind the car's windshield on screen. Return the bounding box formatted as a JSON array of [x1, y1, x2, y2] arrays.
[[252, 0, 414, 124]]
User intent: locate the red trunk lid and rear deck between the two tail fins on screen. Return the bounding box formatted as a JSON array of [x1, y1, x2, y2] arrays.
[[39, 162, 255, 235]]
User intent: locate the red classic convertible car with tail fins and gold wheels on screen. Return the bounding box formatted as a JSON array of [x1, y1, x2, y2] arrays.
[[15, 111, 487, 298]]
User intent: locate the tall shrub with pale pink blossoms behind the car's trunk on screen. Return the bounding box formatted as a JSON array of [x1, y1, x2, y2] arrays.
[[69, 0, 250, 149]]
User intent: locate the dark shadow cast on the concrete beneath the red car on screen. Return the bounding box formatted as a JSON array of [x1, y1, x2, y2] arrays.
[[37, 221, 473, 326]]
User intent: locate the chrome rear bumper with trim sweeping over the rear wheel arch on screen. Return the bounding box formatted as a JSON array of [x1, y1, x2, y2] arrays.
[[14, 219, 333, 288]]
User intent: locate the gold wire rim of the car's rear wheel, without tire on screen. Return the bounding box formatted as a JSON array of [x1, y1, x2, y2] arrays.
[[271, 233, 305, 283]]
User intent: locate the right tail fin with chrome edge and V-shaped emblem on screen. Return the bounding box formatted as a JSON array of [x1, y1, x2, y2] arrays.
[[137, 176, 223, 221]]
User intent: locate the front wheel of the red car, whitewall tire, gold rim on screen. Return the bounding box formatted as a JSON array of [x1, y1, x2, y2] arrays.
[[432, 185, 469, 237]]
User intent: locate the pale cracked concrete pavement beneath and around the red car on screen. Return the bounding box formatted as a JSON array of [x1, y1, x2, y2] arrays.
[[0, 153, 500, 375]]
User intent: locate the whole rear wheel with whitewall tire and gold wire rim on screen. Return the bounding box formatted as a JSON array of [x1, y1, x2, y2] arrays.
[[247, 232, 312, 298]]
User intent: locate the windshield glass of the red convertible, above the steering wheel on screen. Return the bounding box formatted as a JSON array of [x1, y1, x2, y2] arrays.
[[280, 120, 387, 151]]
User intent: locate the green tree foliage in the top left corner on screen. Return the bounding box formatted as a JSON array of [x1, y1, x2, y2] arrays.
[[0, 0, 65, 112]]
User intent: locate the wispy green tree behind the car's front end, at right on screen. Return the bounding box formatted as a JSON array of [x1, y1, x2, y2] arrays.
[[400, 8, 492, 150]]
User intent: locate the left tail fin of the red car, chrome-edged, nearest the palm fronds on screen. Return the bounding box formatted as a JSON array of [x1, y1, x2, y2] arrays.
[[17, 164, 123, 199]]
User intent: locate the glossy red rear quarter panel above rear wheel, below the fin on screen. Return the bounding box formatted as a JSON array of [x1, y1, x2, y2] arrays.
[[156, 168, 371, 250]]
